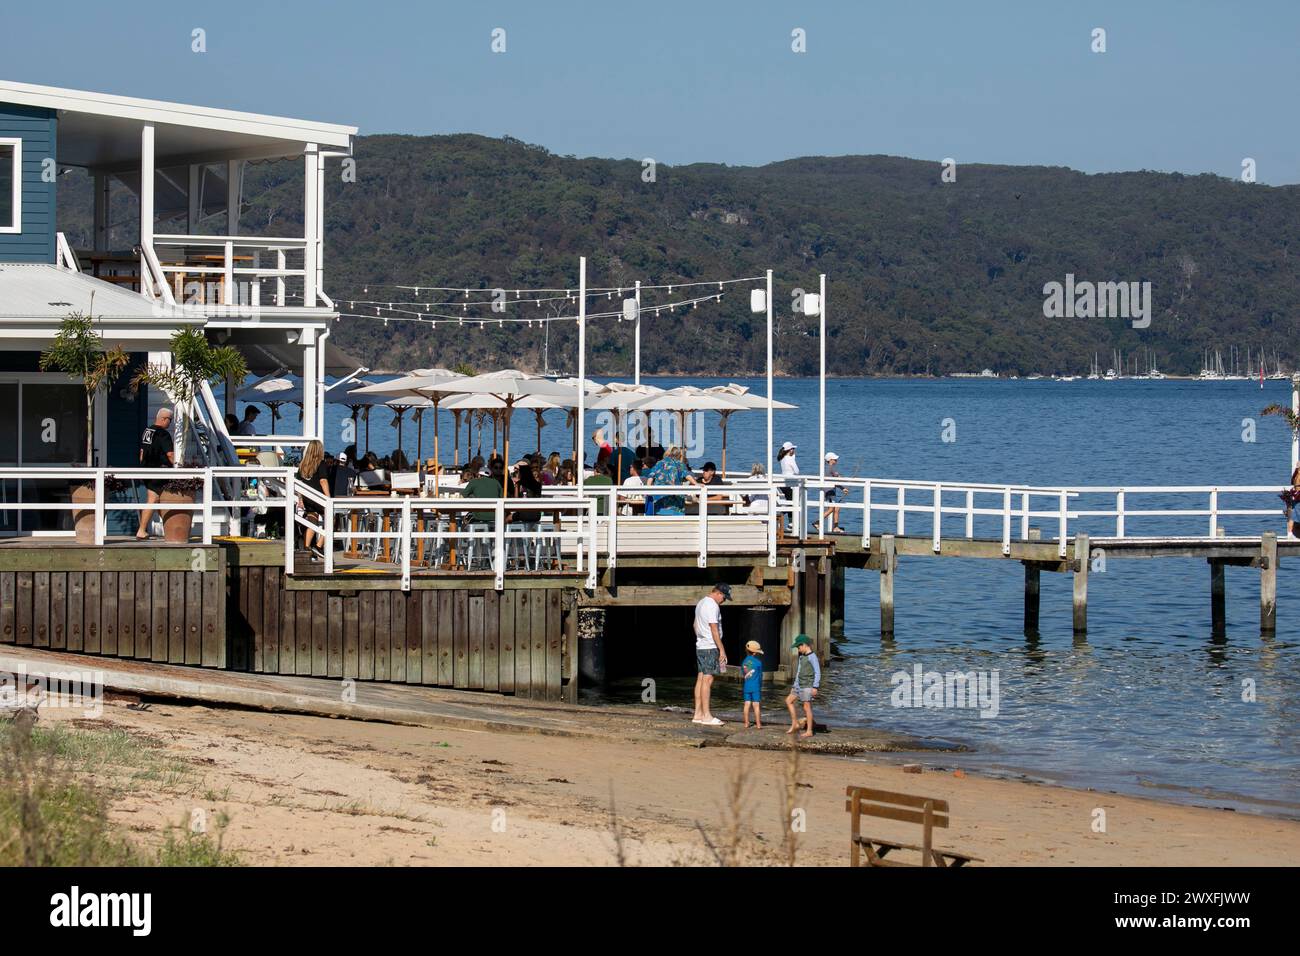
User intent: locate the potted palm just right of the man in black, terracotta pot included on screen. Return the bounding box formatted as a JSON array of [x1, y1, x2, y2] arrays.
[[131, 329, 248, 544]]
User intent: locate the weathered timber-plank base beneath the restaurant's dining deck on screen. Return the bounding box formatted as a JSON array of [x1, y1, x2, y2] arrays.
[[0, 538, 833, 700]]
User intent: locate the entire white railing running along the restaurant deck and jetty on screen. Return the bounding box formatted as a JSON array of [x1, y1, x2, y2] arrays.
[[0, 466, 1282, 580]]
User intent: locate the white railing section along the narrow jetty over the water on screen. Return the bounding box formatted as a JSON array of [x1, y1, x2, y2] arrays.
[[784, 476, 1282, 557]]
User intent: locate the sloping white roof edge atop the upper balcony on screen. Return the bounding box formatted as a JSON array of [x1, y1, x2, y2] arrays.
[[0, 79, 358, 147]]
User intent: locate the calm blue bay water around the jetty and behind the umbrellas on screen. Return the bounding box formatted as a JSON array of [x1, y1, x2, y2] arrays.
[[241, 380, 1300, 816]]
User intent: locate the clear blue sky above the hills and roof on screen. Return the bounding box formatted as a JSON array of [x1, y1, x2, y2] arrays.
[[0, 0, 1300, 183]]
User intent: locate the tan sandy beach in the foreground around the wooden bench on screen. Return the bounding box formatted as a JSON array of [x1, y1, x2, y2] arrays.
[[30, 696, 1300, 866]]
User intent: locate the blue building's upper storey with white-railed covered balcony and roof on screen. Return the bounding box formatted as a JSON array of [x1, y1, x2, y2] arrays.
[[0, 81, 356, 326]]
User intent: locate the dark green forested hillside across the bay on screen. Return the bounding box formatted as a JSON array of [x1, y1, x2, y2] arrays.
[[65, 135, 1300, 375]]
